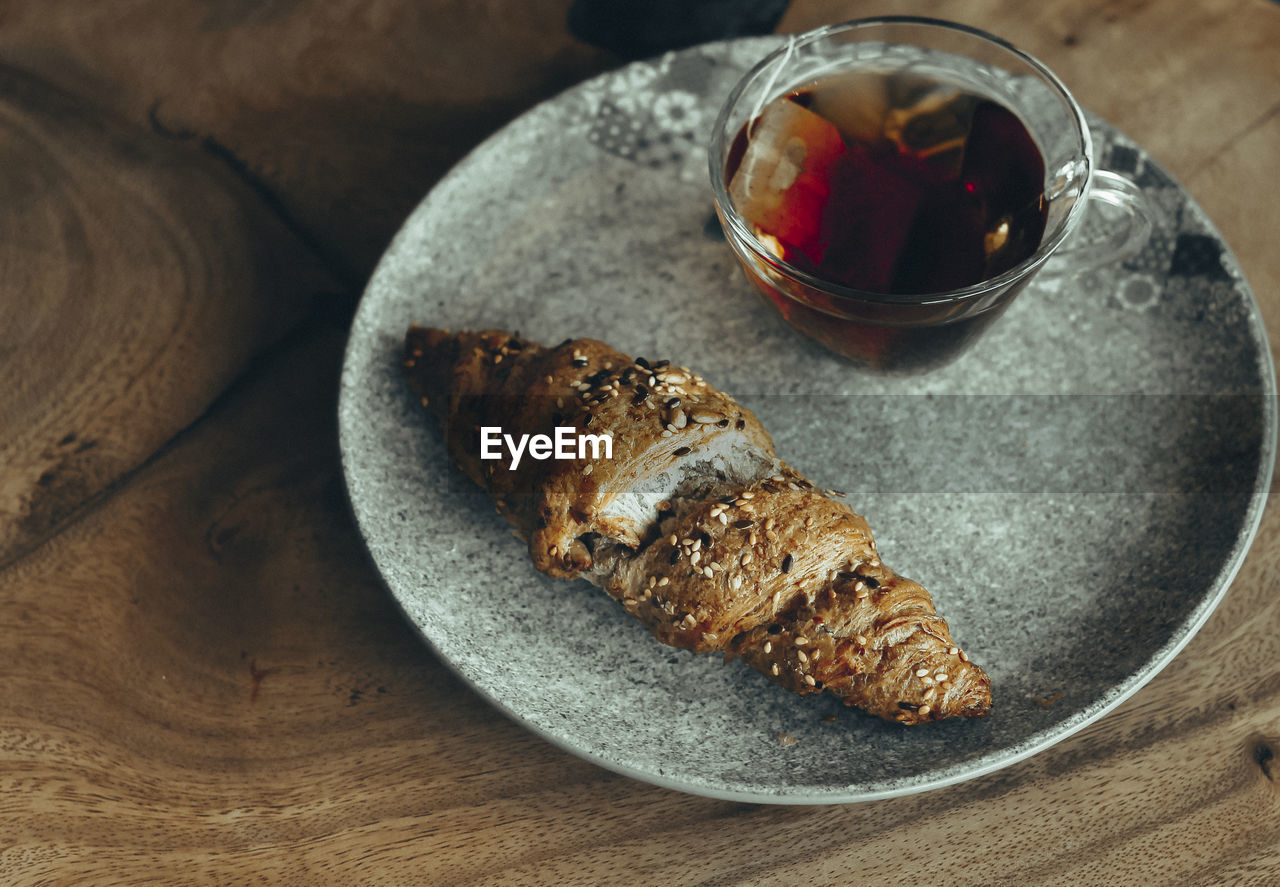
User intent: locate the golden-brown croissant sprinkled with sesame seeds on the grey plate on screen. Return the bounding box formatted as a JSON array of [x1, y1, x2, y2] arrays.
[[404, 326, 991, 724]]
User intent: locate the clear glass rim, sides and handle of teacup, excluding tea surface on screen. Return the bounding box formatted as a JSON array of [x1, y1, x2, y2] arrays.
[[709, 17, 1152, 374]]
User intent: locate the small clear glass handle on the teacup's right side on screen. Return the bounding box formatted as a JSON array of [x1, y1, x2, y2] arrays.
[[1046, 169, 1155, 276]]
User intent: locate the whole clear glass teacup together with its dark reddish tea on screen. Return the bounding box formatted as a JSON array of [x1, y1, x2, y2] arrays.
[[709, 17, 1151, 372]]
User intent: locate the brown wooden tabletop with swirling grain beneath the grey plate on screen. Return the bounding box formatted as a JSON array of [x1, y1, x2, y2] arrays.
[[0, 0, 1280, 884]]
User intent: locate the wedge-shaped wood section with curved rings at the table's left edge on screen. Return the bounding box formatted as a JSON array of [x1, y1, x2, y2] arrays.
[[0, 68, 334, 563]]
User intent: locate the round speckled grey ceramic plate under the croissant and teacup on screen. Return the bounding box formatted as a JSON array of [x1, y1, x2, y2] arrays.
[[340, 38, 1275, 804]]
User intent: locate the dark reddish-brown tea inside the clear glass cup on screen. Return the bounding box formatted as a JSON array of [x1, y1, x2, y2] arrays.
[[724, 70, 1048, 370]]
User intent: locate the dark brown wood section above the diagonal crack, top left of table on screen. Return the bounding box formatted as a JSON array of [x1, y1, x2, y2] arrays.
[[0, 0, 612, 276]]
